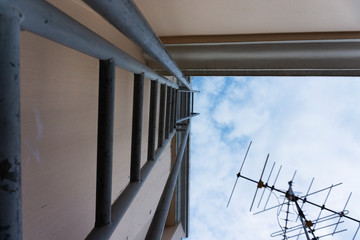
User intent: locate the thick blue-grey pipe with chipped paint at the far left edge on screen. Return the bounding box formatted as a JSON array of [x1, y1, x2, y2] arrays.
[[0, 4, 22, 240]]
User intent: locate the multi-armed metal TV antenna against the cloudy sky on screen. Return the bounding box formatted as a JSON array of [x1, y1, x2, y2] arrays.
[[227, 141, 360, 240]]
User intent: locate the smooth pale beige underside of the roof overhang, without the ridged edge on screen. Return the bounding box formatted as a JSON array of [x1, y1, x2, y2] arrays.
[[135, 0, 360, 36]]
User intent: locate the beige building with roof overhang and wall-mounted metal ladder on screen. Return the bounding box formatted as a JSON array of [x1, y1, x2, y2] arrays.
[[0, 0, 360, 239]]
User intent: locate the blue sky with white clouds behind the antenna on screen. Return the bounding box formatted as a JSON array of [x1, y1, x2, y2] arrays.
[[189, 77, 360, 240]]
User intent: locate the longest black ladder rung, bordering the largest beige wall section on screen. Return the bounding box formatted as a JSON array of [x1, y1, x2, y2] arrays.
[[95, 59, 115, 227]]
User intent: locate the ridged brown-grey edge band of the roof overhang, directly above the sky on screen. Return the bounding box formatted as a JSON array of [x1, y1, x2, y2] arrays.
[[145, 32, 360, 76]]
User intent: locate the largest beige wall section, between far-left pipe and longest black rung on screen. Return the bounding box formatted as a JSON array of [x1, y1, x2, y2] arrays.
[[20, 32, 98, 239]]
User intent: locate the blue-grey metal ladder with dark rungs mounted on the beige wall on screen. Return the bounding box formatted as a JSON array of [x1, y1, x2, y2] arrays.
[[0, 0, 197, 239]]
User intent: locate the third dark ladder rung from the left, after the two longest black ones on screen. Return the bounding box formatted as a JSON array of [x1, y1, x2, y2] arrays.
[[147, 81, 158, 161]]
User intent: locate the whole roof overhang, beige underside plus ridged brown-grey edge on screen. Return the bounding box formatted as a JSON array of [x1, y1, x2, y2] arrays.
[[134, 0, 360, 76]]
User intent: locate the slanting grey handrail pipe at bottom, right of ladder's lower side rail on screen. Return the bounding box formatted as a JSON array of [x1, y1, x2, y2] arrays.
[[145, 123, 190, 240]]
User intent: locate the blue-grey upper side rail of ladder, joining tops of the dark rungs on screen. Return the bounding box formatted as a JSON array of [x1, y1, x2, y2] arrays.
[[11, 0, 178, 88]]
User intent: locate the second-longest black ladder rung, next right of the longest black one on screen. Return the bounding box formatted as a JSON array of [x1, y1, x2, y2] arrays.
[[130, 73, 144, 182]]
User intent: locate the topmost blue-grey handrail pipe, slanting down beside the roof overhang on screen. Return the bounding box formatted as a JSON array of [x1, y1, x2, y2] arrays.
[[83, 0, 191, 90]]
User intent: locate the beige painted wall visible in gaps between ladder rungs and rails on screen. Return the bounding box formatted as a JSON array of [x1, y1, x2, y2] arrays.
[[20, 1, 171, 240]]
